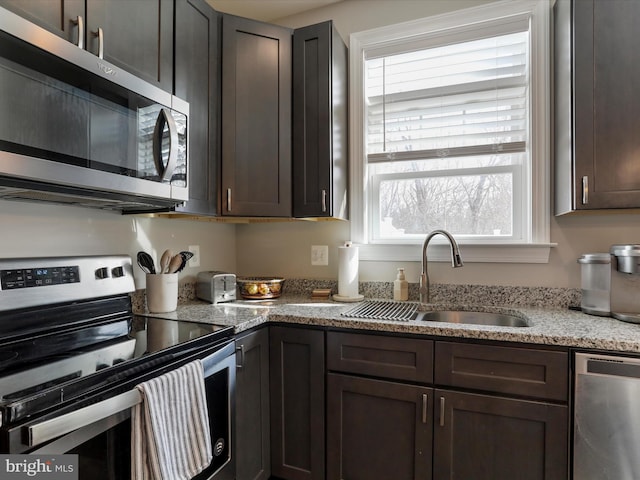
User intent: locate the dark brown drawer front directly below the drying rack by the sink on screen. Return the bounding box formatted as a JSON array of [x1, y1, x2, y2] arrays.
[[327, 332, 433, 383]]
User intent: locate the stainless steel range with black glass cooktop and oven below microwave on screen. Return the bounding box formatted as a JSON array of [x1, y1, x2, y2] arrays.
[[0, 256, 235, 480]]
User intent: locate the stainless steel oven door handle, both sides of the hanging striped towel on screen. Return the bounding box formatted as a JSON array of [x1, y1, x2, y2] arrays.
[[22, 342, 236, 447]]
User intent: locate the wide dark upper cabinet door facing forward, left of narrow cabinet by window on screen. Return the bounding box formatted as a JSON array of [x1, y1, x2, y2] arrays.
[[221, 15, 291, 217]]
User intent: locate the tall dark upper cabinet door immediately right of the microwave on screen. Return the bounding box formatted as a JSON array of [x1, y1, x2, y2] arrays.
[[174, 0, 220, 215]]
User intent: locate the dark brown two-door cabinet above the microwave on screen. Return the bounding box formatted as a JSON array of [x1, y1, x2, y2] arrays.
[[0, 0, 173, 92]]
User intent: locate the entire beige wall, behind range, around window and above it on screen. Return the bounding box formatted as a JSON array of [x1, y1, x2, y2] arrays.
[[0, 0, 640, 287]]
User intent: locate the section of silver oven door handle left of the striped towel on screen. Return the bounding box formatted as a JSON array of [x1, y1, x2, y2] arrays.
[[22, 389, 142, 447]]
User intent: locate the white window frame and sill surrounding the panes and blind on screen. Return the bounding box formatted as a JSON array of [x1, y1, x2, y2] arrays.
[[349, 0, 556, 263]]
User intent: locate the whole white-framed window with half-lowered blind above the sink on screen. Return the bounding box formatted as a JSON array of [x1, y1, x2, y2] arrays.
[[350, 0, 550, 262]]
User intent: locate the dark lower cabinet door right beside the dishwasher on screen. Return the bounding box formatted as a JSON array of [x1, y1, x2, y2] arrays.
[[433, 390, 568, 480]]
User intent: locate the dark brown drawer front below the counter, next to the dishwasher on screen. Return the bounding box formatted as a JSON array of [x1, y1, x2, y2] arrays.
[[435, 342, 569, 401]]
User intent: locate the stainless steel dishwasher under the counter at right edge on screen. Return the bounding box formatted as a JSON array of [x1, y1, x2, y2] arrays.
[[573, 353, 640, 480]]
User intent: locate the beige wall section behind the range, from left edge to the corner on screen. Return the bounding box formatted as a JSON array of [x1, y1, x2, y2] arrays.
[[0, 201, 236, 288]]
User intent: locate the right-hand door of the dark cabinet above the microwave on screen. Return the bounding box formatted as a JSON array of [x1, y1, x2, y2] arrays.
[[85, 0, 173, 92]]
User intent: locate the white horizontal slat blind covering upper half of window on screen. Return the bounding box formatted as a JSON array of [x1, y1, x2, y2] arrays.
[[365, 29, 529, 163]]
